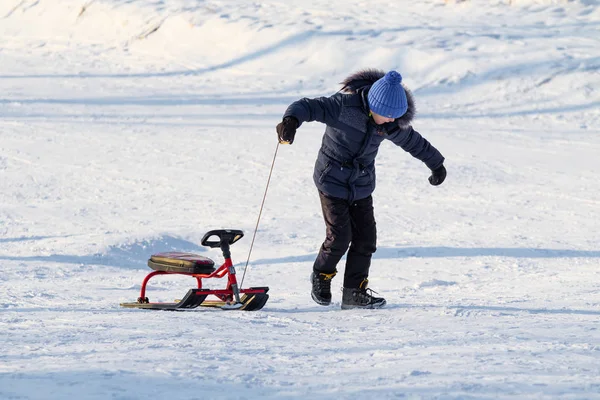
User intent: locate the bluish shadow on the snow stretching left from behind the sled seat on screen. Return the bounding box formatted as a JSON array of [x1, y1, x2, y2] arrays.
[[0, 235, 206, 268]]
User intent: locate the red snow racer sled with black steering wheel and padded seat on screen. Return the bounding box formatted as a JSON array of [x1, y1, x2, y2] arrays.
[[121, 229, 269, 311]]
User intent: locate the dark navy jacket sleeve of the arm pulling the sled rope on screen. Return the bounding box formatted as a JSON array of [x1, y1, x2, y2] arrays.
[[283, 95, 342, 125]]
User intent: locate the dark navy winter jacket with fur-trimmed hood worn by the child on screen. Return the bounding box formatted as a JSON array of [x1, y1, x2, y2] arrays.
[[284, 69, 444, 202]]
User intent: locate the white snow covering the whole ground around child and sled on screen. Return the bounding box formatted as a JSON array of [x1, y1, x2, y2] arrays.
[[0, 0, 600, 400]]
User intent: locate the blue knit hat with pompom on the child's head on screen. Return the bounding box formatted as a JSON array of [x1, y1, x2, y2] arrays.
[[368, 71, 408, 118]]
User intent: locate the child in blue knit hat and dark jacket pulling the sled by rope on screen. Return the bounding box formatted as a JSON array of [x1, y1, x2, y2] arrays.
[[276, 69, 446, 309]]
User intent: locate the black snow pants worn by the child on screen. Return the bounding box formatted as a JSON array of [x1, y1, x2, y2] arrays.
[[313, 192, 377, 288]]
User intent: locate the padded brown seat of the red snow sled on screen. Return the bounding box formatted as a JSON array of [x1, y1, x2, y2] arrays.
[[148, 251, 215, 274]]
